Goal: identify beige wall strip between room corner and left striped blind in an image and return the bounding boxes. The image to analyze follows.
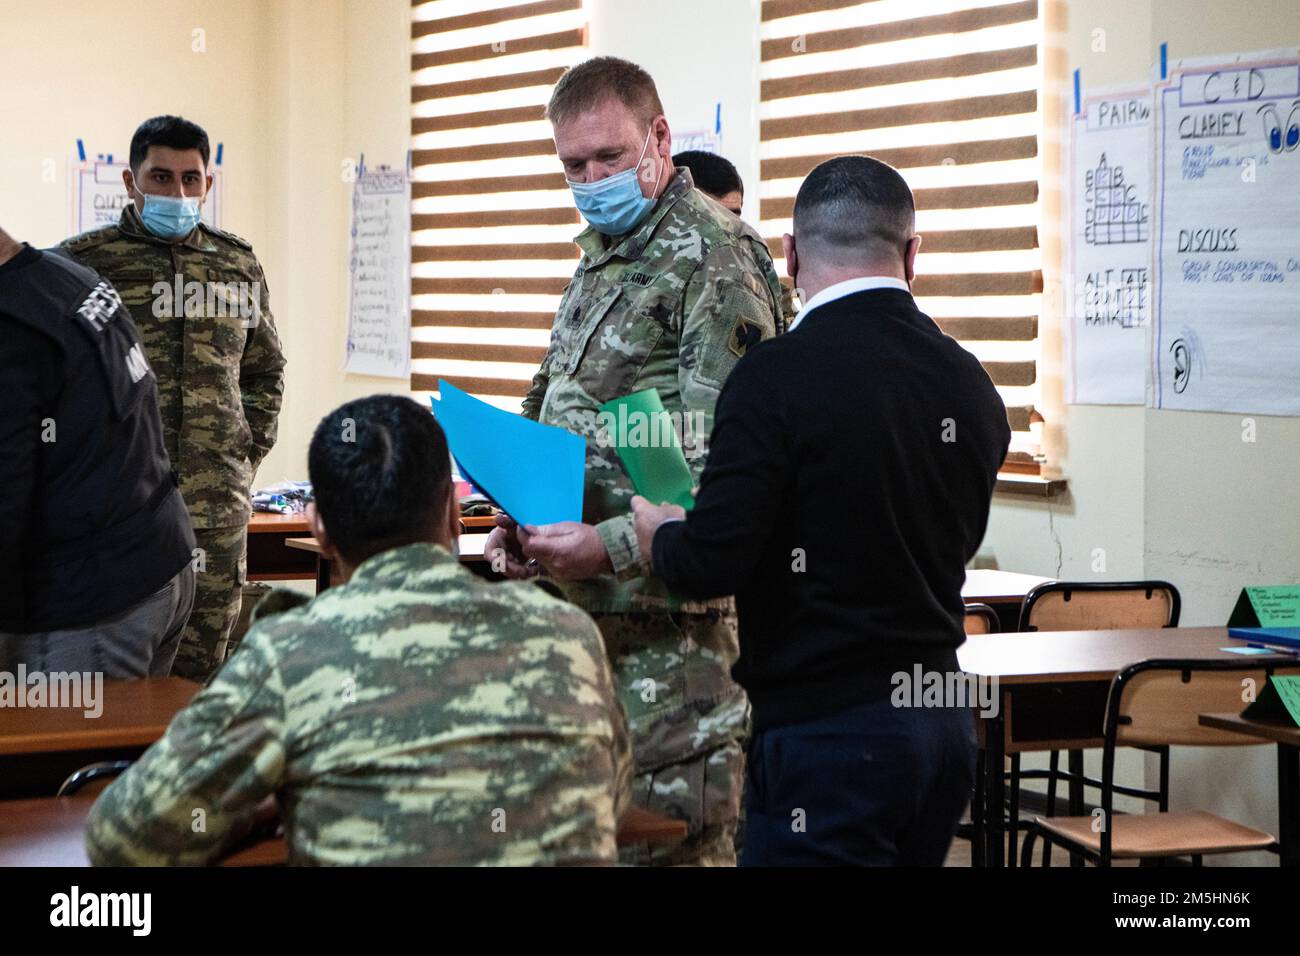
[259,0,411,484]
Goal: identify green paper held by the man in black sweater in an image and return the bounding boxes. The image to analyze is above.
[599,389,696,511]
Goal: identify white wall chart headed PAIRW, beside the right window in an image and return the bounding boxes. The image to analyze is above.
[1065,88,1152,405]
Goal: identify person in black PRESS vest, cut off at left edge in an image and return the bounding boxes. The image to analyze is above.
[0,230,194,680]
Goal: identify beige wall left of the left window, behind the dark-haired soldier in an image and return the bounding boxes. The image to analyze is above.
[0,0,411,494]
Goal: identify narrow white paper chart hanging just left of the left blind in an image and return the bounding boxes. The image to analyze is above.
[343,168,411,378]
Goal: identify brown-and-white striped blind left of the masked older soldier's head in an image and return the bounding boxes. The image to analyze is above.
[411,0,586,411]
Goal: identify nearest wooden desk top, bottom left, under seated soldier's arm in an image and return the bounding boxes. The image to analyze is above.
[0,793,289,868]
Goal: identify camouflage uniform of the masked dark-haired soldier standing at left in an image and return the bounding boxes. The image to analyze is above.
[62,206,285,680]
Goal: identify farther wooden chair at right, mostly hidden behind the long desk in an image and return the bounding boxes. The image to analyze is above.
[1008,580,1182,866]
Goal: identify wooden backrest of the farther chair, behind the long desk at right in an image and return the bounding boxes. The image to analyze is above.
[1021,581,1182,631]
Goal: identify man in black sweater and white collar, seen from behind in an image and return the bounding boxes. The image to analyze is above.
[633,156,1010,865]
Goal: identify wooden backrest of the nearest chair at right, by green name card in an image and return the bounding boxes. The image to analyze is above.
[1106,661,1300,747]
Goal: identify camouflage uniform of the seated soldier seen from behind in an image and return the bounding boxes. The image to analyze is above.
[86,544,632,865]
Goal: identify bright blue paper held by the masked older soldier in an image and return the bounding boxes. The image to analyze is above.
[432,378,586,524]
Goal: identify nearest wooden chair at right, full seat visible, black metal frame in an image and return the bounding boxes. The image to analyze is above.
[1021,659,1297,866]
